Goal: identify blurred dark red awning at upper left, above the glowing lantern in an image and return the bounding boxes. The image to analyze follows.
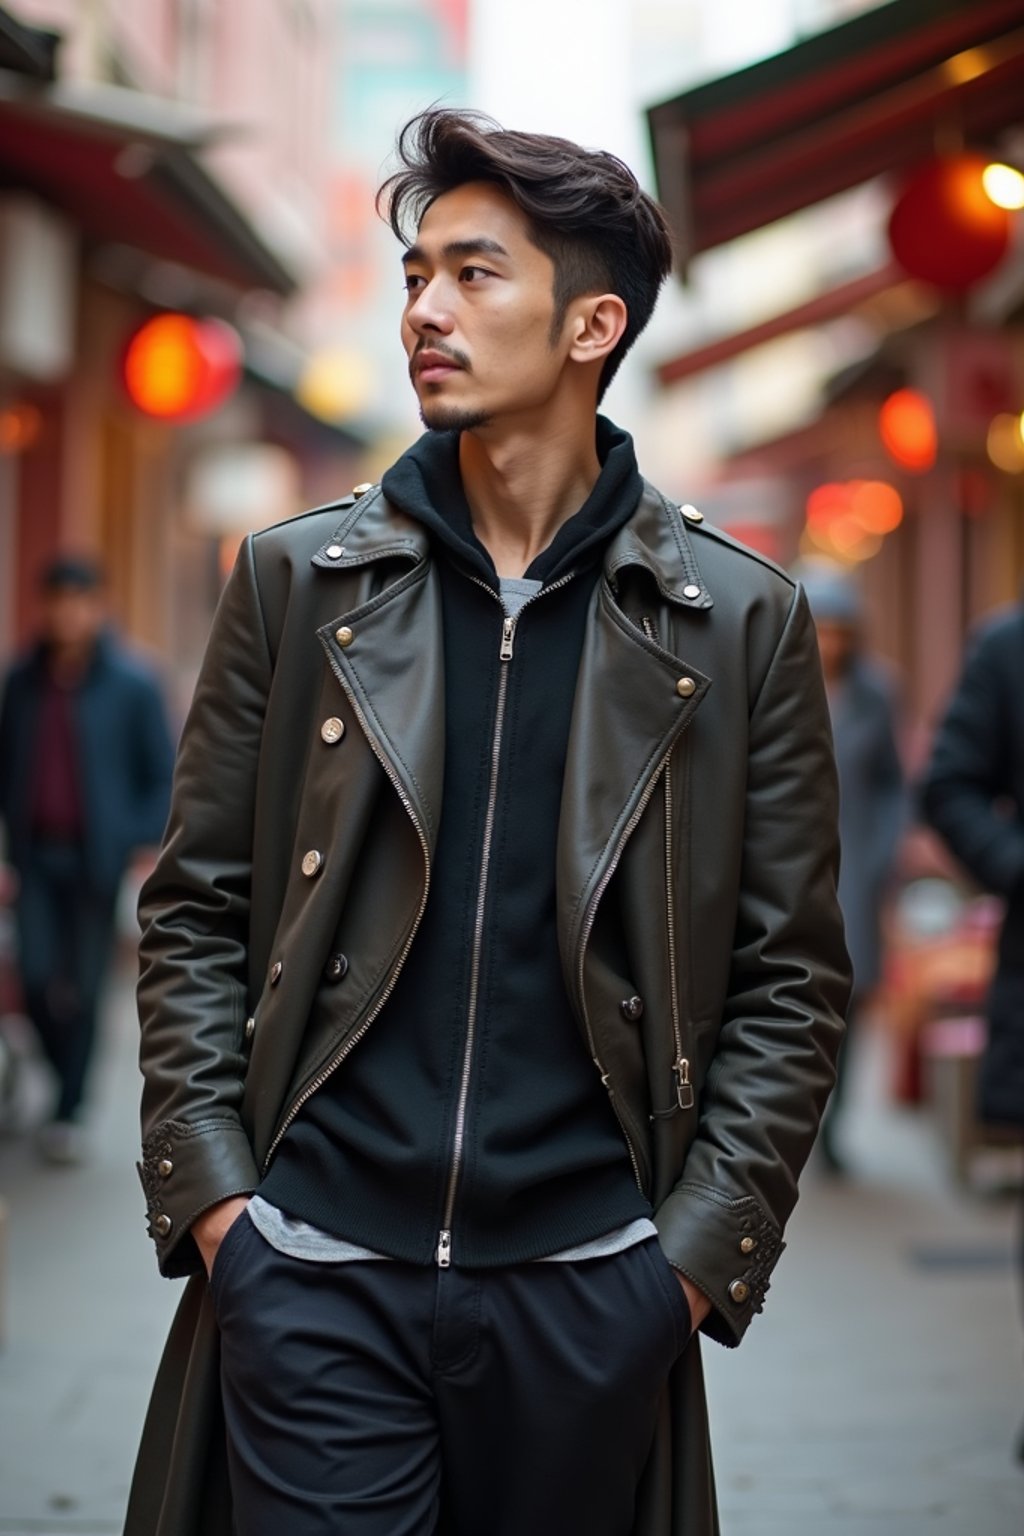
[0,69,298,293]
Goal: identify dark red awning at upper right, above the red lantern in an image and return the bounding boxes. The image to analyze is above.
[648,0,1024,275]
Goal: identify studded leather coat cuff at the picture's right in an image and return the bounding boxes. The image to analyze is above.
[654,1183,786,1346]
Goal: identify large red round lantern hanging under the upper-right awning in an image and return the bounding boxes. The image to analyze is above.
[889,154,1010,293]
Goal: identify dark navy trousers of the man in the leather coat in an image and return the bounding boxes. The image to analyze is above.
[212,1215,689,1536]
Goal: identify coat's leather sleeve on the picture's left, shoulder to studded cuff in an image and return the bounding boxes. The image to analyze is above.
[138,539,272,1275]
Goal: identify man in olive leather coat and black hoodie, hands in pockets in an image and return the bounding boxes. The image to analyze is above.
[127,111,847,1536]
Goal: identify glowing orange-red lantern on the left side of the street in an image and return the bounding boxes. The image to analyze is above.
[124,313,243,421]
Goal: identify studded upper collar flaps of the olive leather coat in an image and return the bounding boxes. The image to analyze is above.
[313,481,714,608]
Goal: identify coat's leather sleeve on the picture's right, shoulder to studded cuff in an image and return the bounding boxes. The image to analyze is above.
[654,590,851,1344]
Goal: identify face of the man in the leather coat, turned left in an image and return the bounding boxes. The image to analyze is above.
[402,181,571,432]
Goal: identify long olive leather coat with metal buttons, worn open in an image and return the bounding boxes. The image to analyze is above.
[126,487,849,1536]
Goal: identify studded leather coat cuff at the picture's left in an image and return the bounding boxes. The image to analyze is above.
[137,1120,259,1276]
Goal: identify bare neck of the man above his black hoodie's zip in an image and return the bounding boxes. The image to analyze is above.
[459,416,600,578]
